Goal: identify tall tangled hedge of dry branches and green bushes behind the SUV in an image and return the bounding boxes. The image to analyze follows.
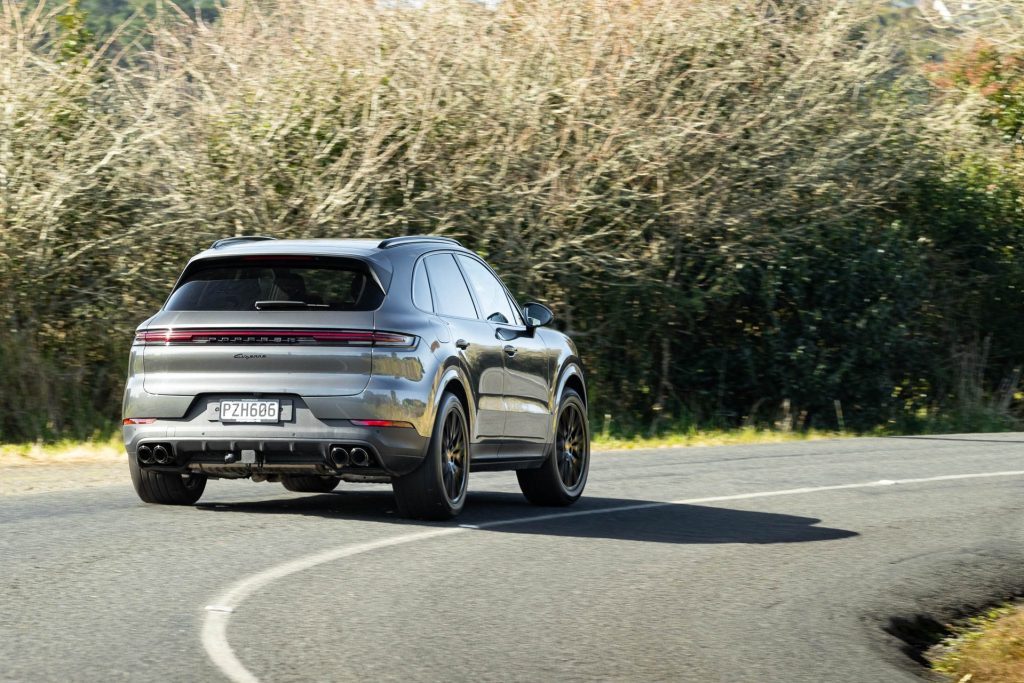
[0,0,1024,442]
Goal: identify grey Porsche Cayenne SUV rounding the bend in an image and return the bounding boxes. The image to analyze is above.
[123,237,590,519]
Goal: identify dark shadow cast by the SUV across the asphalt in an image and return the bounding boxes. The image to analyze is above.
[196,492,857,544]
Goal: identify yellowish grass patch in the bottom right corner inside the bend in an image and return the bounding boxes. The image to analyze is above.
[929,603,1024,683]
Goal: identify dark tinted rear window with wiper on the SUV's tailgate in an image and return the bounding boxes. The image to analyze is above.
[164,257,384,310]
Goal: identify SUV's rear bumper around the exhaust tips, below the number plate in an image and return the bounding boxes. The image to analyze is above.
[123,396,430,477]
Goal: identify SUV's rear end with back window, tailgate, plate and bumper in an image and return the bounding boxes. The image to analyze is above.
[124,240,433,489]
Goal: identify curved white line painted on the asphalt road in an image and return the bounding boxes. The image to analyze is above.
[202,470,1024,683]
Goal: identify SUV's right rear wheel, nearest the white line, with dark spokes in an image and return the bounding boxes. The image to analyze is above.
[392,393,469,519]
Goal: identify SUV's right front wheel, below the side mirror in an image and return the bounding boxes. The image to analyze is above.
[516,389,590,507]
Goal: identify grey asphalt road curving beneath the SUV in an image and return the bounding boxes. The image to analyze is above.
[0,434,1024,683]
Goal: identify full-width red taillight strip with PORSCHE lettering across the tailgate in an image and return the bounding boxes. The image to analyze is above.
[135,329,416,346]
